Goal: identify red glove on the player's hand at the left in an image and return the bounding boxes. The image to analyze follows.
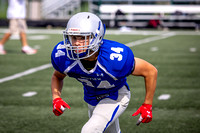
[53,98,70,116]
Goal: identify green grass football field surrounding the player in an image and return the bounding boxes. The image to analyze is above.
[0,28,200,133]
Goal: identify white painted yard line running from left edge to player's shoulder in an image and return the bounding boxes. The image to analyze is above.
[0,64,52,83]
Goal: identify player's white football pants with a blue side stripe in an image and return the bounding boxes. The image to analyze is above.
[81,86,131,133]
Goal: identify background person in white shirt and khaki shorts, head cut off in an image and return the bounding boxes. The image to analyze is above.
[0,0,37,55]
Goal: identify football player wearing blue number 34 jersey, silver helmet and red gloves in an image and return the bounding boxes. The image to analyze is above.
[51,12,157,133]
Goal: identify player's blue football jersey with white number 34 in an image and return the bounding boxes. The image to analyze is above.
[51,39,135,106]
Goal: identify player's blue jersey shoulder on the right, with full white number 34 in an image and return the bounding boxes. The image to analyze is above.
[99,40,135,78]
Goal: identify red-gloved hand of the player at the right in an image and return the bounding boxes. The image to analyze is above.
[132,103,153,126]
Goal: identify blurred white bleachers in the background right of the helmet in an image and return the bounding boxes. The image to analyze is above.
[88,0,200,28]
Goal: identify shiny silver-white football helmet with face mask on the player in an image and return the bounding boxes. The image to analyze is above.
[63,12,105,60]
